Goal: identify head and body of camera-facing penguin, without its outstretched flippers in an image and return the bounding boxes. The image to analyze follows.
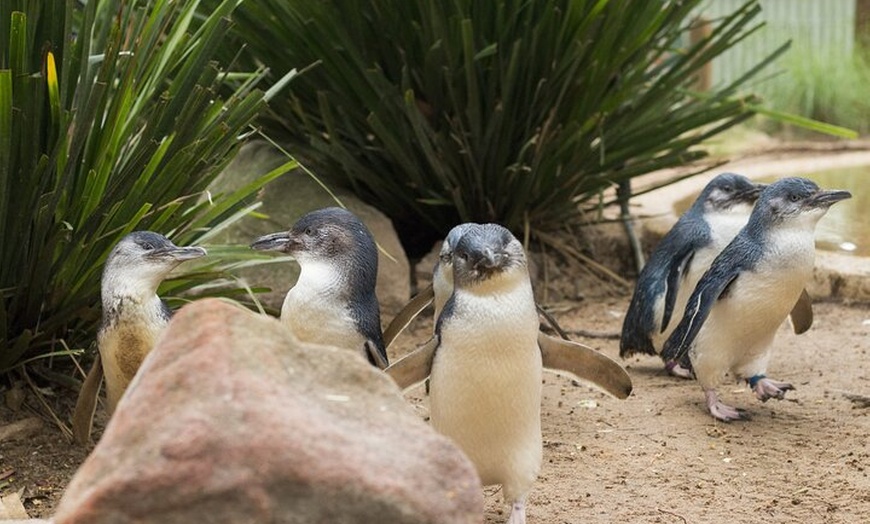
[429,224,543,524]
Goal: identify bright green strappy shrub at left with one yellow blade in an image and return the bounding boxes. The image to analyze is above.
[0,0,291,373]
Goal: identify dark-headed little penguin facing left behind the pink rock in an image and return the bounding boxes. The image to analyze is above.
[251,207,388,369]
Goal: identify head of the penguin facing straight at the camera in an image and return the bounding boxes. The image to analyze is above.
[453,224,526,287]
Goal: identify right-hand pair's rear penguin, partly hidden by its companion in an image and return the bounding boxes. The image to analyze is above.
[619,173,764,378]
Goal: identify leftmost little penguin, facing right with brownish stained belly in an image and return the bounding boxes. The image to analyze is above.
[73,231,206,443]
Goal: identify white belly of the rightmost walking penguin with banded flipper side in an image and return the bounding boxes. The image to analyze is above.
[692,235,814,387]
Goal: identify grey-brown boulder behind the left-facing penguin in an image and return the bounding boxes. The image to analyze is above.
[210,142,411,318]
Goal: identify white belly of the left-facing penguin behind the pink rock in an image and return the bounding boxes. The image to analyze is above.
[281,285,365,353]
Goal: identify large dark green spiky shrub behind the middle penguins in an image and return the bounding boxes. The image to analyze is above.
[215,0,782,255]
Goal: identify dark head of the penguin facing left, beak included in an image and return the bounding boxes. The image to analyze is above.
[251,207,378,272]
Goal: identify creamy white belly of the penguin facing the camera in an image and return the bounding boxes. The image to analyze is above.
[429,290,542,500]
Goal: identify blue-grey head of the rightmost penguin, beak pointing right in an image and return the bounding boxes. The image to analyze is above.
[753,177,852,226]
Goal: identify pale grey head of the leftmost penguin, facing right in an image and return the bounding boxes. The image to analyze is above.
[103,231,206,294]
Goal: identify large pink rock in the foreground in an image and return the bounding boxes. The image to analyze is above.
[55,299,483,524]
